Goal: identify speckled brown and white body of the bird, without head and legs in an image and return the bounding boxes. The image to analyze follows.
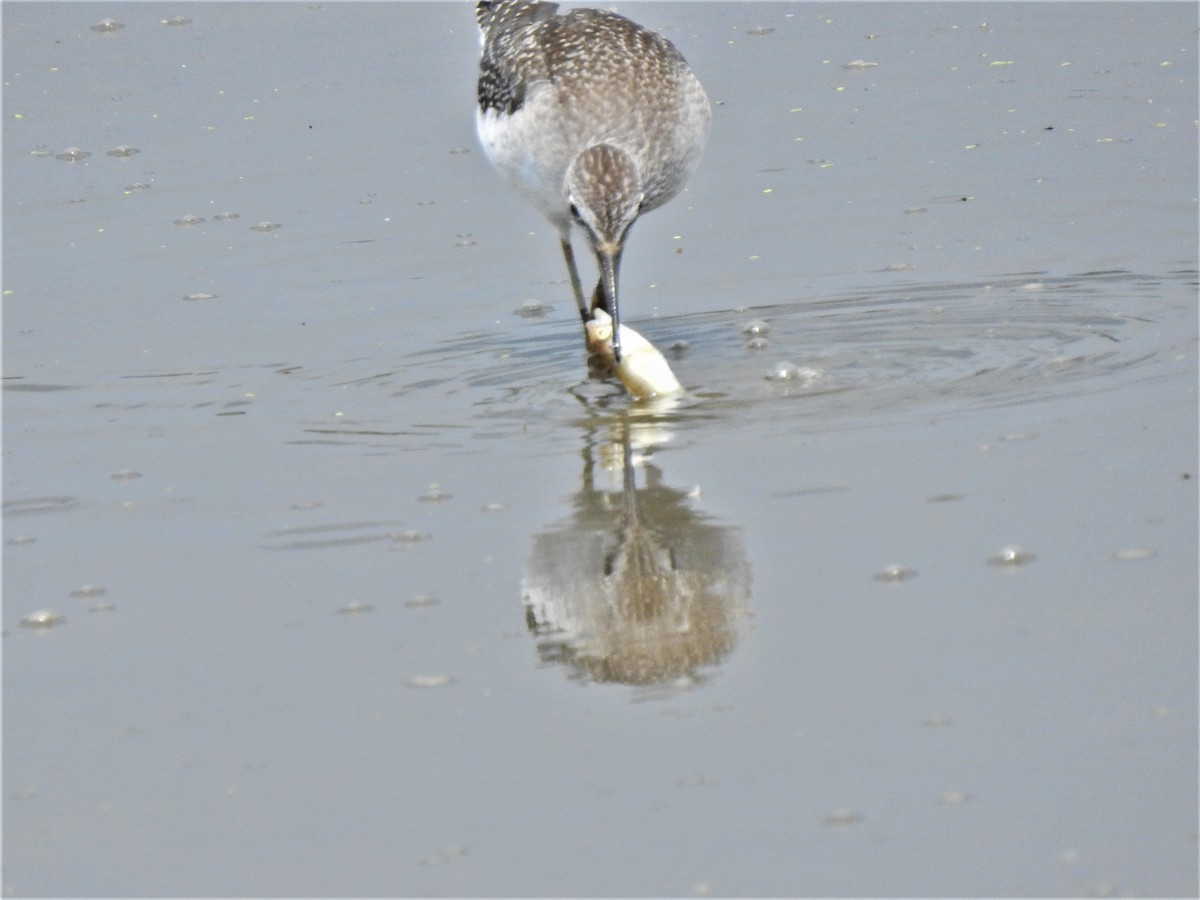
[476,0,712,220]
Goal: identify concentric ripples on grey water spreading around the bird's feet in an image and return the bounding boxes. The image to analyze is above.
[400,271,1195,434]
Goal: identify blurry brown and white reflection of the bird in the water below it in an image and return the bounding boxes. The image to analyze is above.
[522,414,750,686]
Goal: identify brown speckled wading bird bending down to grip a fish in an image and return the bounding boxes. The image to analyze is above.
[475,0,712,362]
